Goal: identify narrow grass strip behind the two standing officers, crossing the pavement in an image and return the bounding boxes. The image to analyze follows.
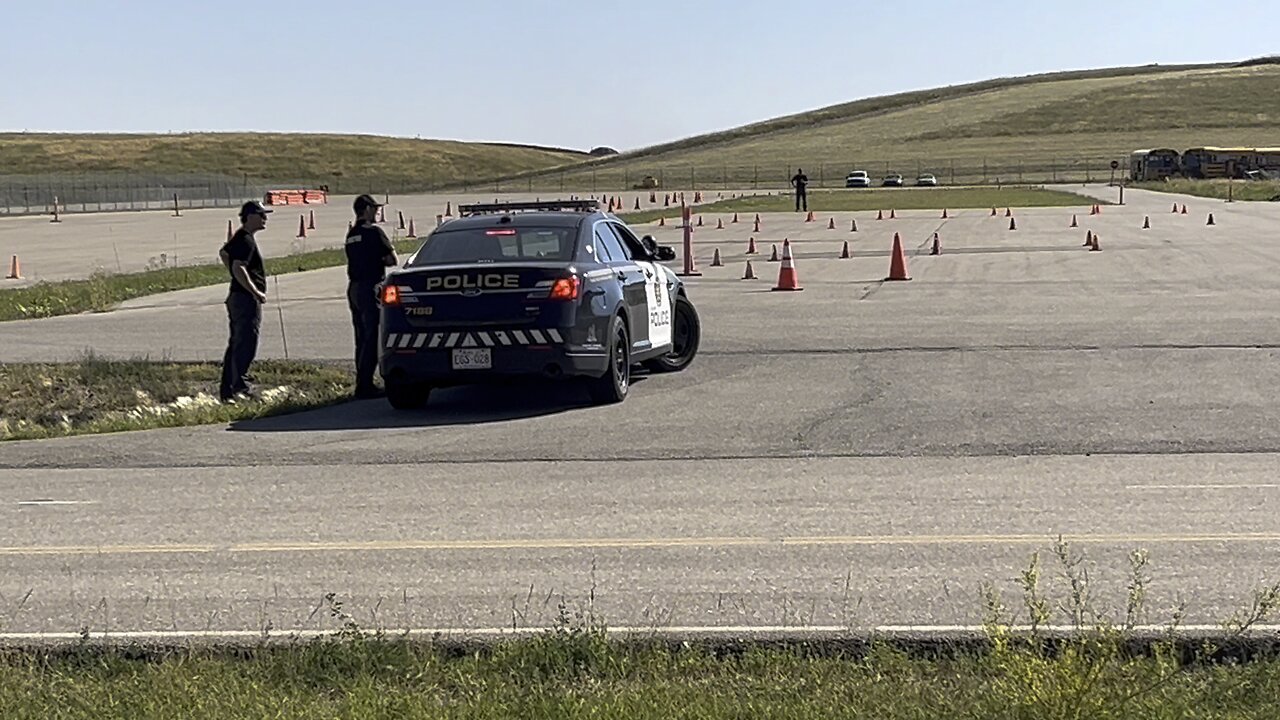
[0,240,421,322]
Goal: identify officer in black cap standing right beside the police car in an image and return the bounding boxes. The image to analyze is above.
[347,195,396,400]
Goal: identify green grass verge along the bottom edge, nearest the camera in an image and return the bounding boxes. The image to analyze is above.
[0,630,1280,720]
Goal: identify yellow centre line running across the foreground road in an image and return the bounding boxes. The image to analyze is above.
[0,533,1280,556]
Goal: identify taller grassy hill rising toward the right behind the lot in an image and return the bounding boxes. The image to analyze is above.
[496,59,1280,190]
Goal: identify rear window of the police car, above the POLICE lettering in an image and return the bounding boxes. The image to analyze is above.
[410,227,577,268]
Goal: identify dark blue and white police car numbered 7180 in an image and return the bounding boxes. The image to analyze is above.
[378,200,701,410]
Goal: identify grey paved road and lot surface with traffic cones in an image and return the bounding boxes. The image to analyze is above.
[0,188,1280,632]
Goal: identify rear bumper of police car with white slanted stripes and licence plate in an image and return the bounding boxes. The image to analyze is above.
[379,331,608,386]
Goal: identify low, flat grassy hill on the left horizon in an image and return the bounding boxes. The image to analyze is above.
[0,133,588,192]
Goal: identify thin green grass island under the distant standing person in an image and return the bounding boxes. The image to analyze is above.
[618,187,1107,223]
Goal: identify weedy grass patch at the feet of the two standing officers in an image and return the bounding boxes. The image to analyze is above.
[0,356,352,439]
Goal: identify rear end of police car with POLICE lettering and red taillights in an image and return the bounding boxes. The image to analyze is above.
[379,202,608,409]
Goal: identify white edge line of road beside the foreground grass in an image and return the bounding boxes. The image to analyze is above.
[0,625,1280,643]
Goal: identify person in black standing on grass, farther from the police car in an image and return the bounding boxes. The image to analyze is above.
[218,201,271,402]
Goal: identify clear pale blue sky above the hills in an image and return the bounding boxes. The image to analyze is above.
[0,0,1280,150]
